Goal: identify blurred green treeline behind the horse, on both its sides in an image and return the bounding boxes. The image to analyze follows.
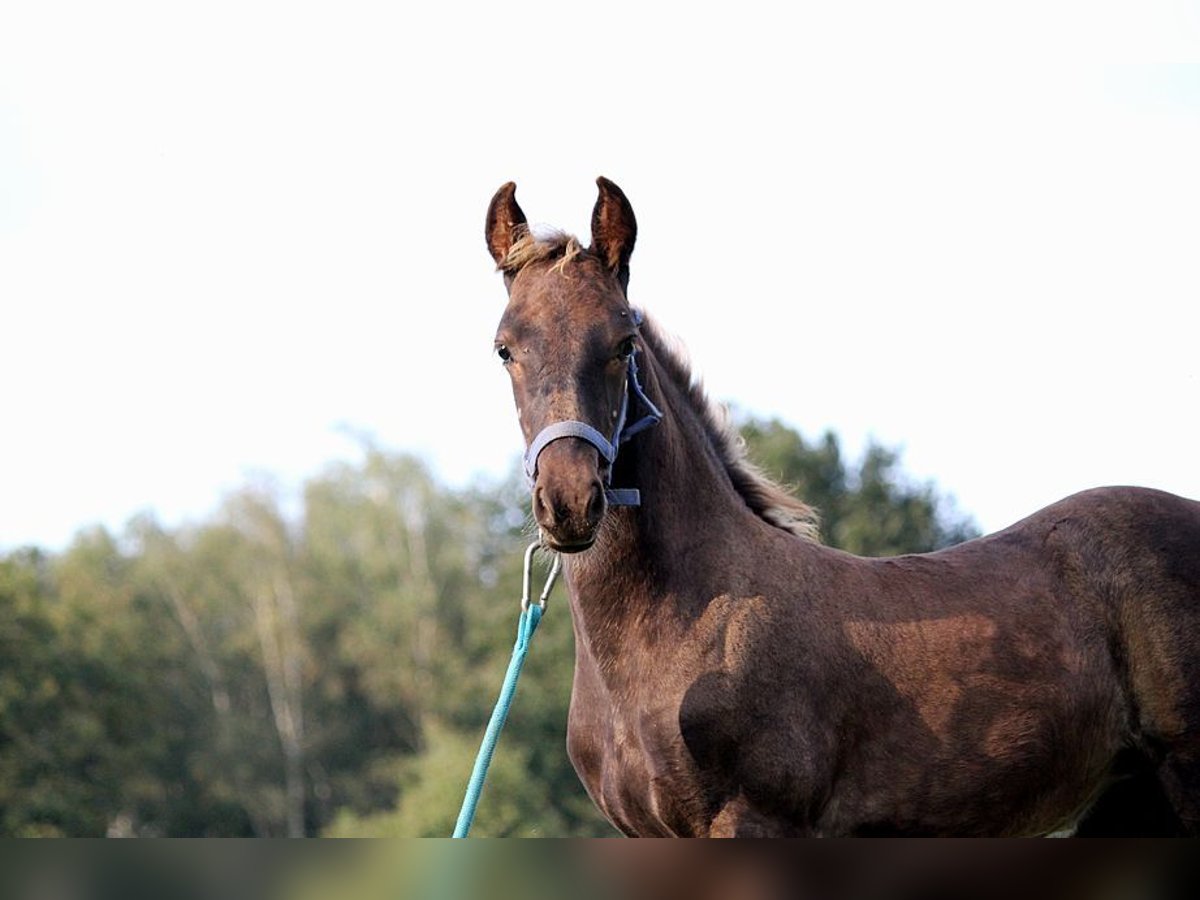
[0,421,974,836]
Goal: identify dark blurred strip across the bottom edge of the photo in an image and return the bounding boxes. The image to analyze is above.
[0,840,1200,900]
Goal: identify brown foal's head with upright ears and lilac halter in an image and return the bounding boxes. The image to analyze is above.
[486,178,659,553]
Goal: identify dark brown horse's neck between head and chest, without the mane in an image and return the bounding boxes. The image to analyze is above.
[565,338,754,637]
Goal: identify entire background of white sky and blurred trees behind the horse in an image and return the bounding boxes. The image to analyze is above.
[0,0,1200,836]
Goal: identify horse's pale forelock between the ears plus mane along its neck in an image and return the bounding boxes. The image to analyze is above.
[499,232,820,541]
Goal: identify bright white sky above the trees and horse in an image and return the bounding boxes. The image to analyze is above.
[0,0,1200,551]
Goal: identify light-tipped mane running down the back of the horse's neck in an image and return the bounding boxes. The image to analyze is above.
[642,320,820,541]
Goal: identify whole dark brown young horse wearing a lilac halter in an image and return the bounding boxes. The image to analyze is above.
[487,179,1200,836]
